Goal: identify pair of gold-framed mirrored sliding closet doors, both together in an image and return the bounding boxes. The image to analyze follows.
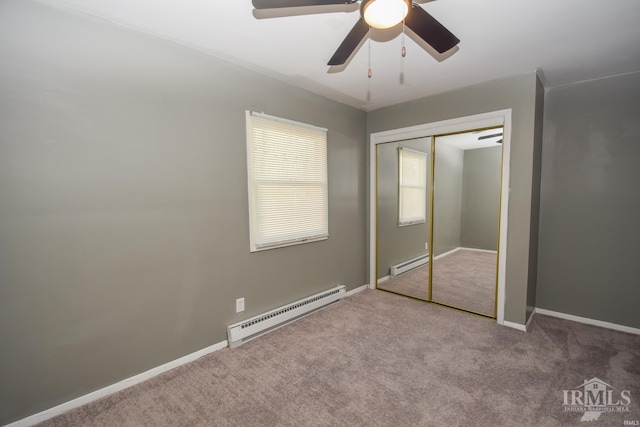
[376,128,502,318]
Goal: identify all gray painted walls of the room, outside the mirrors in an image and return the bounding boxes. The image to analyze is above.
[12,0,640,424]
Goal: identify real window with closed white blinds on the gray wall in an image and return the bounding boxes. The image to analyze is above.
[247,111,329,252]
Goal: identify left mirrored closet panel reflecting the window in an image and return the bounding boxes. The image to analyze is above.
[376,138,431,300]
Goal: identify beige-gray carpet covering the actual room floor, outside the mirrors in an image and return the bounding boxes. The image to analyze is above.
[37,290,640,427]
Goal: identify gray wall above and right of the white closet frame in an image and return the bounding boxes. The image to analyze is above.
[367,72,543,324]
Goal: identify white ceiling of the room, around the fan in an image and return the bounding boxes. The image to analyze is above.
[42,0,640,111]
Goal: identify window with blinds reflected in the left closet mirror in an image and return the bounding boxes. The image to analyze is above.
[398,147,427,226]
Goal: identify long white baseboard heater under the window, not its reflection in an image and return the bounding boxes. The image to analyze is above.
[227,285,347,348]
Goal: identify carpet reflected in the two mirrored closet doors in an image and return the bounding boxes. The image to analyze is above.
[378,250,497,317]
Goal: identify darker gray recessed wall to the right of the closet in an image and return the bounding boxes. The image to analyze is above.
[537,73,640,328]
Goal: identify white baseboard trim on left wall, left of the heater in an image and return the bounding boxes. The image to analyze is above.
[5,340,229,427]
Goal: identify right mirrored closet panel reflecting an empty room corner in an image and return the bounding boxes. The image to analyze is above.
[432,128,502,317]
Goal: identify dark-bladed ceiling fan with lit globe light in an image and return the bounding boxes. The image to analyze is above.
[252,0,460,66]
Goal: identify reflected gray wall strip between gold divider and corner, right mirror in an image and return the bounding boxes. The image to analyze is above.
[433,138,464,256]
